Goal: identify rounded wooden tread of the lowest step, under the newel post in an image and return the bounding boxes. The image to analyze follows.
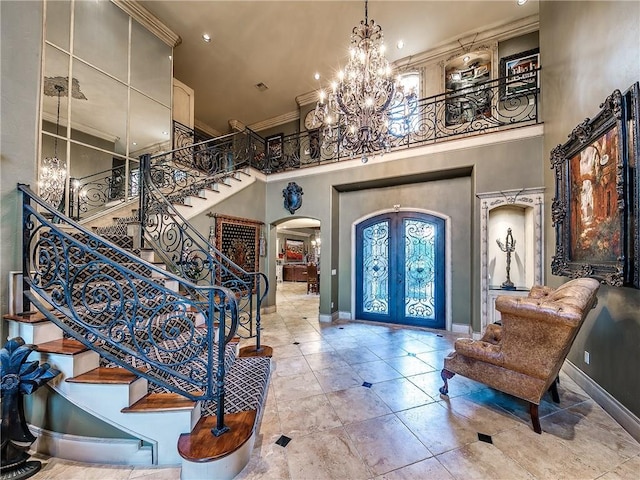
[178,410,257,462]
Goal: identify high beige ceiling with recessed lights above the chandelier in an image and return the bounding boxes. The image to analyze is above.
[140,0,538,133]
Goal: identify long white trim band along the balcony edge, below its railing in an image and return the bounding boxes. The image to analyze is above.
[265,124,544,183]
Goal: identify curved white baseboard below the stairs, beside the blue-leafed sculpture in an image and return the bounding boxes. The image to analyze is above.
[29,425,153,465]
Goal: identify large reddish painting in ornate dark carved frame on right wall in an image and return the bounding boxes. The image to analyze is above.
[551,90,630,286]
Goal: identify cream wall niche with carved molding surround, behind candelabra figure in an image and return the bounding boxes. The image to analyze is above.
[476,187,544,332]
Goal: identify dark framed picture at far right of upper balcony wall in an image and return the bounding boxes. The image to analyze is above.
[500,48,540,100]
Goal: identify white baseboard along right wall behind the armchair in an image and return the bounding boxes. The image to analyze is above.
[562,360,640,442]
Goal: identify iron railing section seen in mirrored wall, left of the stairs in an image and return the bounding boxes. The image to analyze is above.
[68,165,139,220]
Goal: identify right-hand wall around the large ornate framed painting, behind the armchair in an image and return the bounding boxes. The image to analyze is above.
[540,1,640,416]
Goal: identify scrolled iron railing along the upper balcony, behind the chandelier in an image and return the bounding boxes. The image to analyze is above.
[251,70,540,174]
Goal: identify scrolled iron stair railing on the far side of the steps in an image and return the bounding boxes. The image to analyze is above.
[140,150,269,350]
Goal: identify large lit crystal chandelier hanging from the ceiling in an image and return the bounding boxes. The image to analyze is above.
[314,1,404,163]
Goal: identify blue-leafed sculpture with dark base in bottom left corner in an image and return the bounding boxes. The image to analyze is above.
[0,337,60,480]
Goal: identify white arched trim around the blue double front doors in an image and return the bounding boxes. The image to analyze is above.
[350,207,452,331]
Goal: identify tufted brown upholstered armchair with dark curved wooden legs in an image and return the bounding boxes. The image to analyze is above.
[440,278,600,433]
